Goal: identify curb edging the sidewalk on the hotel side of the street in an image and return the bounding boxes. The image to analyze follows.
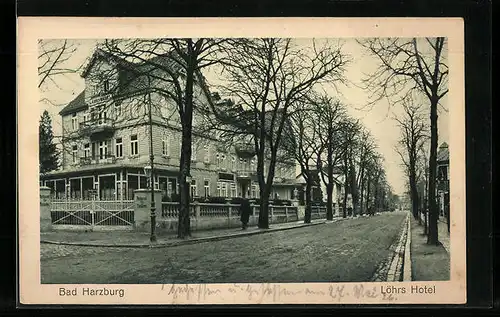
[40,219,336,248]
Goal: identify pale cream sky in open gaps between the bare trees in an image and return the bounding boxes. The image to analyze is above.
[40,39,449,195]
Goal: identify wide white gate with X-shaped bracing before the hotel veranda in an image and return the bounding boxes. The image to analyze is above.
[50,193,134,228]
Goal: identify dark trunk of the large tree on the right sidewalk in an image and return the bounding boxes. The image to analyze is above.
[427,96,439,245]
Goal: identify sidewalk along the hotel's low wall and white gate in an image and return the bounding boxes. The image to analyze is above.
[40,218,342,248]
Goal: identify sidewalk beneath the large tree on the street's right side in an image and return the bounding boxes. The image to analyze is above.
[410,217,450,281]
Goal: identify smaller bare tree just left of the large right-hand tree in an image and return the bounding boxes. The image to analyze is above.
[394,100,427,219]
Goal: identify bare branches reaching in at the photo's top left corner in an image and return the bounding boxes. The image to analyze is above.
[38,40,80,88]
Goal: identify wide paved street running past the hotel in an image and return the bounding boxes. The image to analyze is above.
[41,212,406,284]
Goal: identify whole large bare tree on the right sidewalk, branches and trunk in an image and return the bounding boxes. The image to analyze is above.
[359,37,449,245]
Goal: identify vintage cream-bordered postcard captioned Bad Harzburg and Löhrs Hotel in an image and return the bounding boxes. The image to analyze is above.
[17,17,467,305]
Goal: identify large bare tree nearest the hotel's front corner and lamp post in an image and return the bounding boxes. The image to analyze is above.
[95,38,225,238]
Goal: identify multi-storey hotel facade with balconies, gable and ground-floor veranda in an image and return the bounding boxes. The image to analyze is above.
[41,49,296,201]
